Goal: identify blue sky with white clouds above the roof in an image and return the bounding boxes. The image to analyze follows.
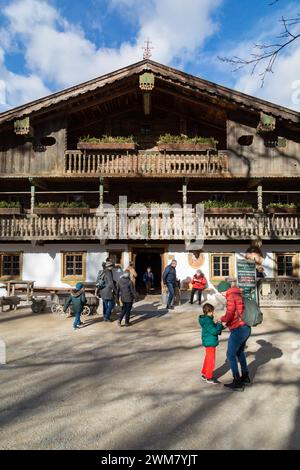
[0,0,300,112]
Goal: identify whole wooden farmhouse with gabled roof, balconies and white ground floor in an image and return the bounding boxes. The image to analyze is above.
[0,60,300,305]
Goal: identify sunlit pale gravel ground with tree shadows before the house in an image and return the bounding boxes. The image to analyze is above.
[0,297,300,450]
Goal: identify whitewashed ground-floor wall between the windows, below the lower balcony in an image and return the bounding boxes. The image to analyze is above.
[0,243,300,287]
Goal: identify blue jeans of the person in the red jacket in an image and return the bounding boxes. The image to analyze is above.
[227,325,251,376]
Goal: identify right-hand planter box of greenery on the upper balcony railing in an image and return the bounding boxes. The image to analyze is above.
[157,134,218,152]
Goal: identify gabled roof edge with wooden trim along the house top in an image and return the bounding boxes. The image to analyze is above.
[0,60,300,124]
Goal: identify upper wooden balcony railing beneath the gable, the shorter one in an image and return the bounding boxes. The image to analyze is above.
[64,150,229,177]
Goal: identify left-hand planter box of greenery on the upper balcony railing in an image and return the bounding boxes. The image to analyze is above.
[77,135,136,150]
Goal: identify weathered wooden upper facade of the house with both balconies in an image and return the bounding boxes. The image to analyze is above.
[0,60,300,294]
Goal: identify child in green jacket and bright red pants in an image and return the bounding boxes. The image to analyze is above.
[199,304,224,384]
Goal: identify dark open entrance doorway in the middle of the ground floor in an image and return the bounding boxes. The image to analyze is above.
[135,249,162,294]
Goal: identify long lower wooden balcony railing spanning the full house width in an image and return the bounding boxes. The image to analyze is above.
[0,212,300,242]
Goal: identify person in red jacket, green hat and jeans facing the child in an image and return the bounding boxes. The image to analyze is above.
[217,281,251,391]
